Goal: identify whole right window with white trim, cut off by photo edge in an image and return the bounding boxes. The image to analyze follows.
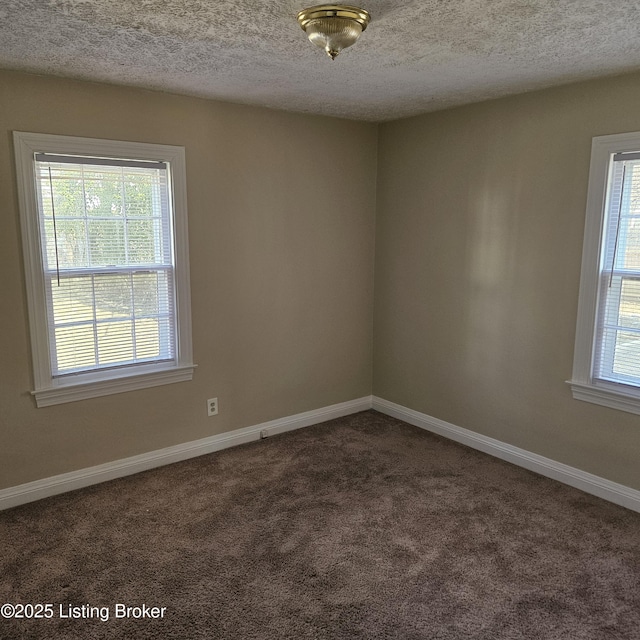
[570,133,640,414]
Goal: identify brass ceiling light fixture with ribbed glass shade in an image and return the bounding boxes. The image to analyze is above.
[298,4,371,60]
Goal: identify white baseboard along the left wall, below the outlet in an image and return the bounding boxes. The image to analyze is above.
[0,396,371,510]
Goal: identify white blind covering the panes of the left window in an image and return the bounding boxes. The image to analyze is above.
[35,153,176,378]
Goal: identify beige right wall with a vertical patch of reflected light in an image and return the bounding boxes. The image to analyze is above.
[374,75,640,489]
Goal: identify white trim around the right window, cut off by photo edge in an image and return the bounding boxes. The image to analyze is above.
[568,132,640,414]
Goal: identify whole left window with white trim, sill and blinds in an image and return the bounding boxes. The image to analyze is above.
[14,132,193,407]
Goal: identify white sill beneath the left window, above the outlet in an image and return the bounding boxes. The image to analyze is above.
[31,365,196,407]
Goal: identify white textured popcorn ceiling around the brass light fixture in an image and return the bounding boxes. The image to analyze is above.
[0,0,640,121]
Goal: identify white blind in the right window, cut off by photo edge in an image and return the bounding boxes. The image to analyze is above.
[593,153,640,386]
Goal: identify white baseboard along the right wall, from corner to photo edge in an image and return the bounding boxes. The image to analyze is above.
[372,396,640,512]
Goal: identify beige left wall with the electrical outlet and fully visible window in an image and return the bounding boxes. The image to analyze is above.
[0,72,377,488]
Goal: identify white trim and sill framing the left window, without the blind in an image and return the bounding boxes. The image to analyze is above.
[13,131,195,407]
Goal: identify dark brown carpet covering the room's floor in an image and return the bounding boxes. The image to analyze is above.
[0,411,640,640]
